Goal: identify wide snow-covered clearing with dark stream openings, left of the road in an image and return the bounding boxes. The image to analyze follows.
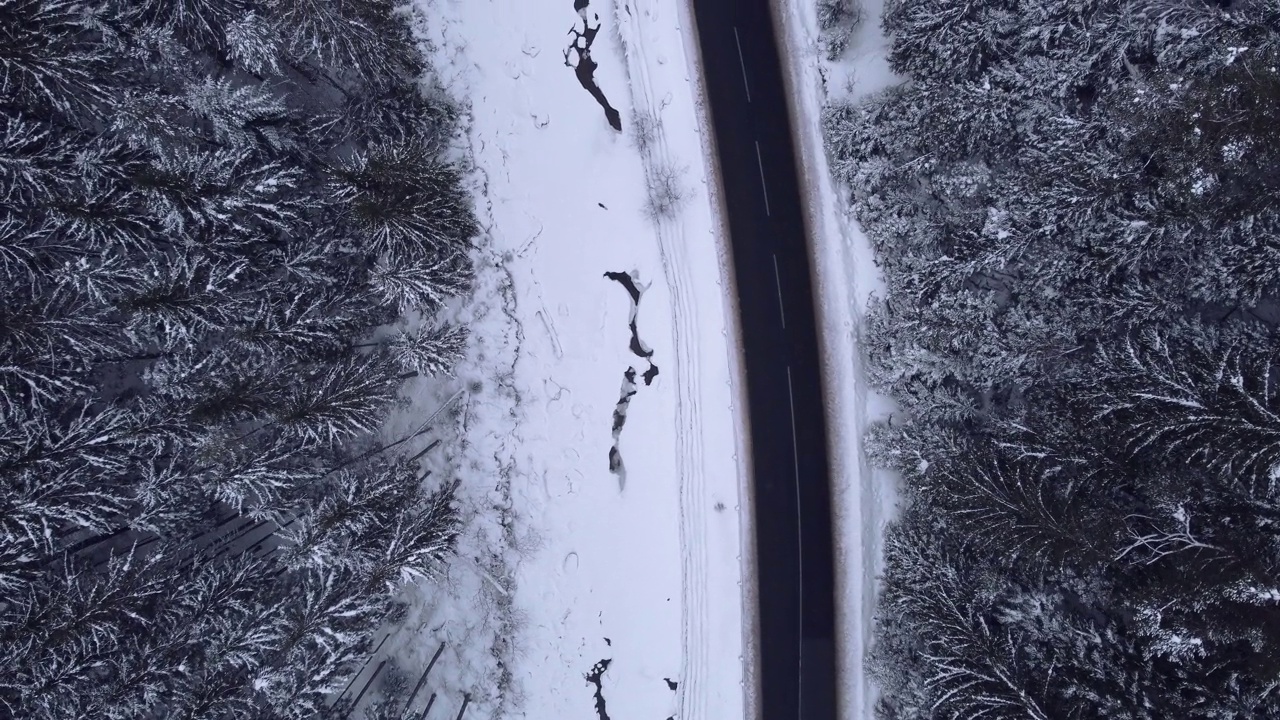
[358,0,754,720]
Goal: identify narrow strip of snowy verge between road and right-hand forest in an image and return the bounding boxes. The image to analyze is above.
[773,0,895,720]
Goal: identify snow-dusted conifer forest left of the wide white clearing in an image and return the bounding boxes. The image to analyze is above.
[0,0,476,720]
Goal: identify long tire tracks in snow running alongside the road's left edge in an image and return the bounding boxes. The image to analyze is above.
[614,0,710,720]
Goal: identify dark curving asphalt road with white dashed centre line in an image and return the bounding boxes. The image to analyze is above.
[694,0,836,720]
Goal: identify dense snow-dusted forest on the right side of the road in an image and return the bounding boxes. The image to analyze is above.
[824,0,1280,720]
